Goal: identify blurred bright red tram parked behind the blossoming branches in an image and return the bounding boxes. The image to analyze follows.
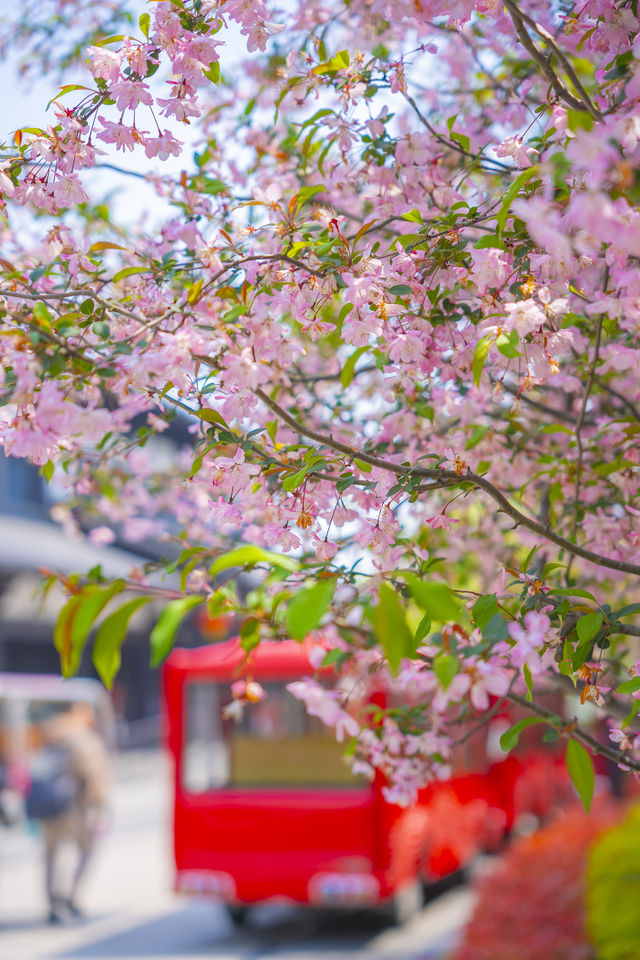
[164,640,561,919]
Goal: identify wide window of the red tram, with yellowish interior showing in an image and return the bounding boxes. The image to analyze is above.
[182,682,362,793]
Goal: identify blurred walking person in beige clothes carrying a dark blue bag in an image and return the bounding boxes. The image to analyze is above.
[26,703,109,924]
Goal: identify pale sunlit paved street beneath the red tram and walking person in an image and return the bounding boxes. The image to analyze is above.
[0,753,471,960]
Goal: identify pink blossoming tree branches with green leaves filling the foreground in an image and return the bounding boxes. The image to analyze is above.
[0,0,640,802]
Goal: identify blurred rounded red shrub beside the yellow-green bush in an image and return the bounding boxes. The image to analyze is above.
[452,803,617,960]
